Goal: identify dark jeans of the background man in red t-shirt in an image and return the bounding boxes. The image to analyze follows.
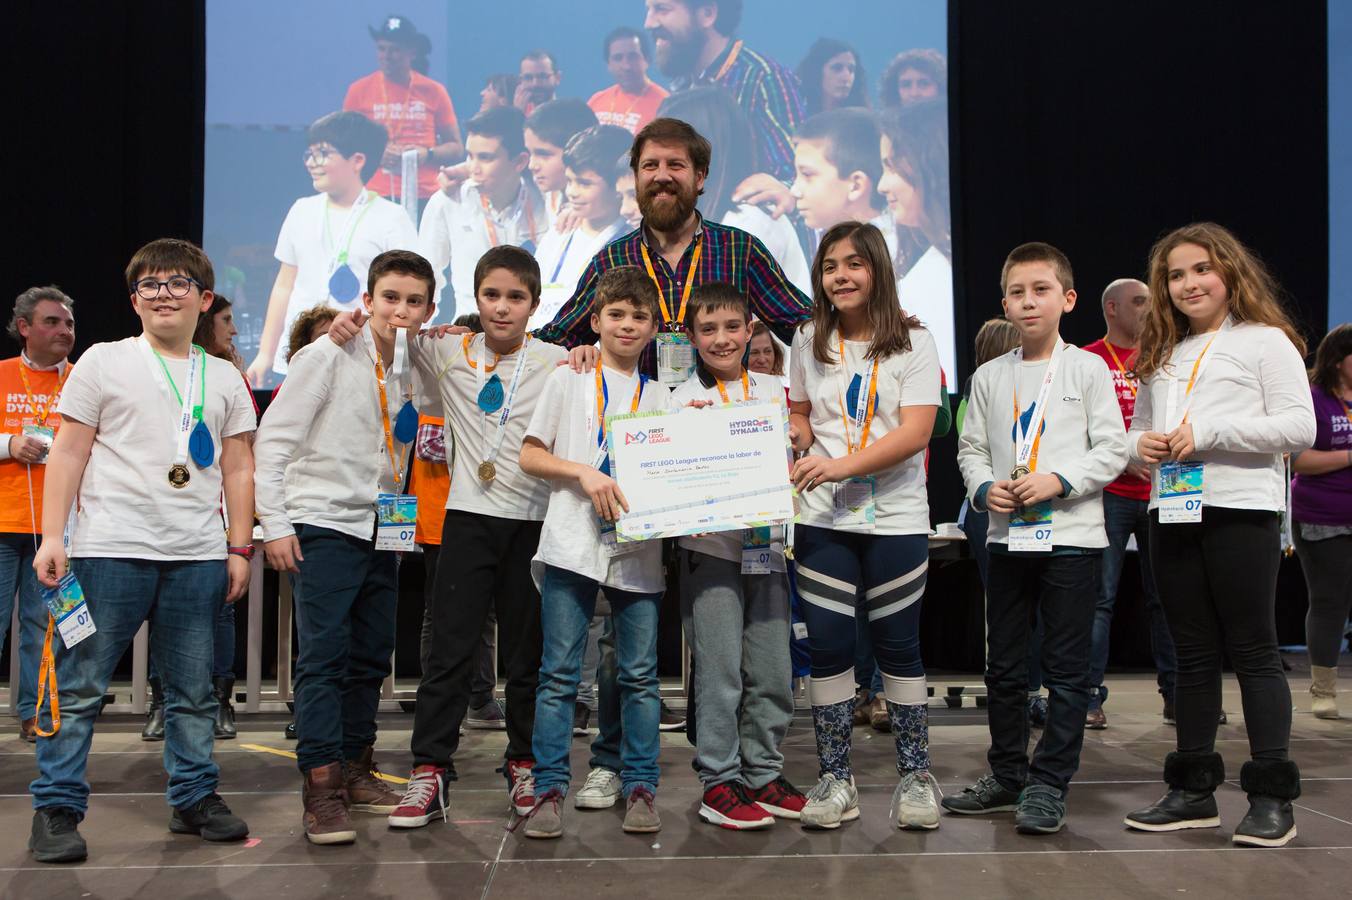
[1090,491,1178,705]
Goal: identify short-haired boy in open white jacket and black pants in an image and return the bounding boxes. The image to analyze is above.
[944,243,1126,834]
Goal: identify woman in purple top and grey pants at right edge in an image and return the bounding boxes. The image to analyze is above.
[1291,323,1352,719]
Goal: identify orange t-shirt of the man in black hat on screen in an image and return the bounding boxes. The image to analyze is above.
[342,72,456,200]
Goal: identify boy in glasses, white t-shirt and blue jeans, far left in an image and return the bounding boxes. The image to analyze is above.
[28,239,256,862]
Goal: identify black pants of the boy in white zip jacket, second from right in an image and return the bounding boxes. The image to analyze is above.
[986,551,1102,791]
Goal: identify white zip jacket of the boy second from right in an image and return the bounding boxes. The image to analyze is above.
[957,347,1128,547]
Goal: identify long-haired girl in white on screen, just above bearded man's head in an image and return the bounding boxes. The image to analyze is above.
[657,86,811,293]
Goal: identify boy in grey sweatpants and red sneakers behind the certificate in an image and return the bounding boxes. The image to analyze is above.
[672,282,807,831]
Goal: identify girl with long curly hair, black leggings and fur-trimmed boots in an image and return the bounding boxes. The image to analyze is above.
[1126,223,1315,847]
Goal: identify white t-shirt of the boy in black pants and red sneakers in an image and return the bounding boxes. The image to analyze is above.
[416,334,568,522]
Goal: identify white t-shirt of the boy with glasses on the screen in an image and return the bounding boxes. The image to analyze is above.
[272,192,418,374]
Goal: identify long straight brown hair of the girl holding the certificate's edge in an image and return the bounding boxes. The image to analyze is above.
[804,222,921,365]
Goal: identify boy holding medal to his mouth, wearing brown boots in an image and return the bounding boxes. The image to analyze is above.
[254,250,437,845]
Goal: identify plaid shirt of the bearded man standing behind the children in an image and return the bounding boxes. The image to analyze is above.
[535,214,813,378]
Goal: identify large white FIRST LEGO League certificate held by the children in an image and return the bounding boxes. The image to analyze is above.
[608,401,796,542]
